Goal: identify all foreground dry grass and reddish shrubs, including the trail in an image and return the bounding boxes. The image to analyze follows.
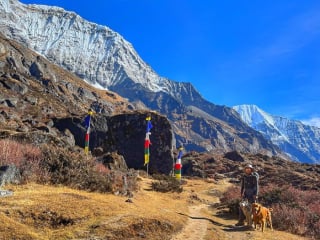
[0,140,320,240]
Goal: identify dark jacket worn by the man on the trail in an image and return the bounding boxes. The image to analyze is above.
[241,172,259,201]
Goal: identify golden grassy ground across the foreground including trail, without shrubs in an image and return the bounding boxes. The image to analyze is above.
[0,177,310,240]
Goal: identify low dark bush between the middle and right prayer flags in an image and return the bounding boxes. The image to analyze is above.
[151,175,183,193]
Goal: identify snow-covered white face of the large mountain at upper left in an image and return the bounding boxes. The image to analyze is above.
[0,0,168,91]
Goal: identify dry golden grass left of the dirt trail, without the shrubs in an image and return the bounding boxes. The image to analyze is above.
[0,179,186,239]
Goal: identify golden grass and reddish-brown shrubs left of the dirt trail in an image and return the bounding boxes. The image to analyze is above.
[0,140,183,239]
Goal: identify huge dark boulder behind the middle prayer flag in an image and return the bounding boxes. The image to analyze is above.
[103,112,174,174]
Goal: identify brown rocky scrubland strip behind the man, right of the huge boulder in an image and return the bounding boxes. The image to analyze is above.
[182,151,320,191]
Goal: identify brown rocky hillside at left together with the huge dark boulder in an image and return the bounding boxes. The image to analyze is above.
[0,34,175,174]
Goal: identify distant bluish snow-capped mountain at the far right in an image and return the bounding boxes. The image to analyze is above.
[233,105,320,163]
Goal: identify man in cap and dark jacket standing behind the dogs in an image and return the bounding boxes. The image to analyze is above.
[236,164,259,226]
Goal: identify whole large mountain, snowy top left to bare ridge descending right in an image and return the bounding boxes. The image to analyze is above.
[0,0,279,155]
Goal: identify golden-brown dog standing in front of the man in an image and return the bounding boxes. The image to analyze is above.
[251,203,273,232]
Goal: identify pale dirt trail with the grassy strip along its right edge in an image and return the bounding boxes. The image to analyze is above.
[172,180,308,240]
